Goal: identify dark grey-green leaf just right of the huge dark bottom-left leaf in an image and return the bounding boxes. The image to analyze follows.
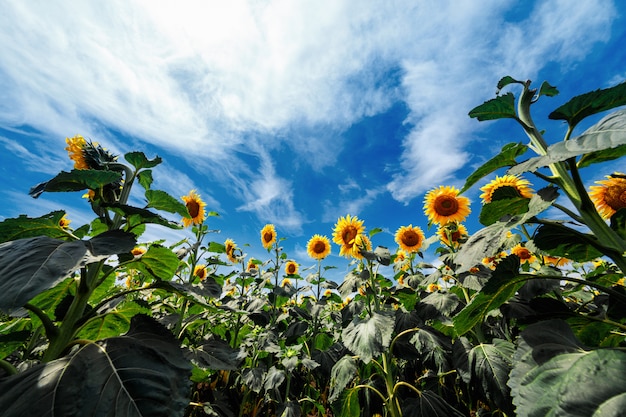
[185,335,245,371]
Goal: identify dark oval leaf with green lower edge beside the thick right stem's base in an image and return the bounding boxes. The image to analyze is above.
[533,223,603,262]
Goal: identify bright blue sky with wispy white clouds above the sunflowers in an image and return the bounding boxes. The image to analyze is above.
[0,0,626,280]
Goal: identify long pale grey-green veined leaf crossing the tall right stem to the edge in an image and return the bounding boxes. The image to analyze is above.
[508,110,626,175]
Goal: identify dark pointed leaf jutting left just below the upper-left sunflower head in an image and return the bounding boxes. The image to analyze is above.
[28,169,122,198]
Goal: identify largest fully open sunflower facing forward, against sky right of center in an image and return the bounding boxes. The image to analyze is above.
[424,185,470,224]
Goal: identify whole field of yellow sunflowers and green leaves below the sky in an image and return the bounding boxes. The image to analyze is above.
[0,76,626,417]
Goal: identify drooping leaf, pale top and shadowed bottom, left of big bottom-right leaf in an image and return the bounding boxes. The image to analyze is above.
[468,339,515,413]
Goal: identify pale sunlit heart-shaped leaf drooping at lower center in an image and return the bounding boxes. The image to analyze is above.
[341,311,395,363]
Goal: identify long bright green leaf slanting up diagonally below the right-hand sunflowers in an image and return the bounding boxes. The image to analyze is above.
[454,255,526,336]
